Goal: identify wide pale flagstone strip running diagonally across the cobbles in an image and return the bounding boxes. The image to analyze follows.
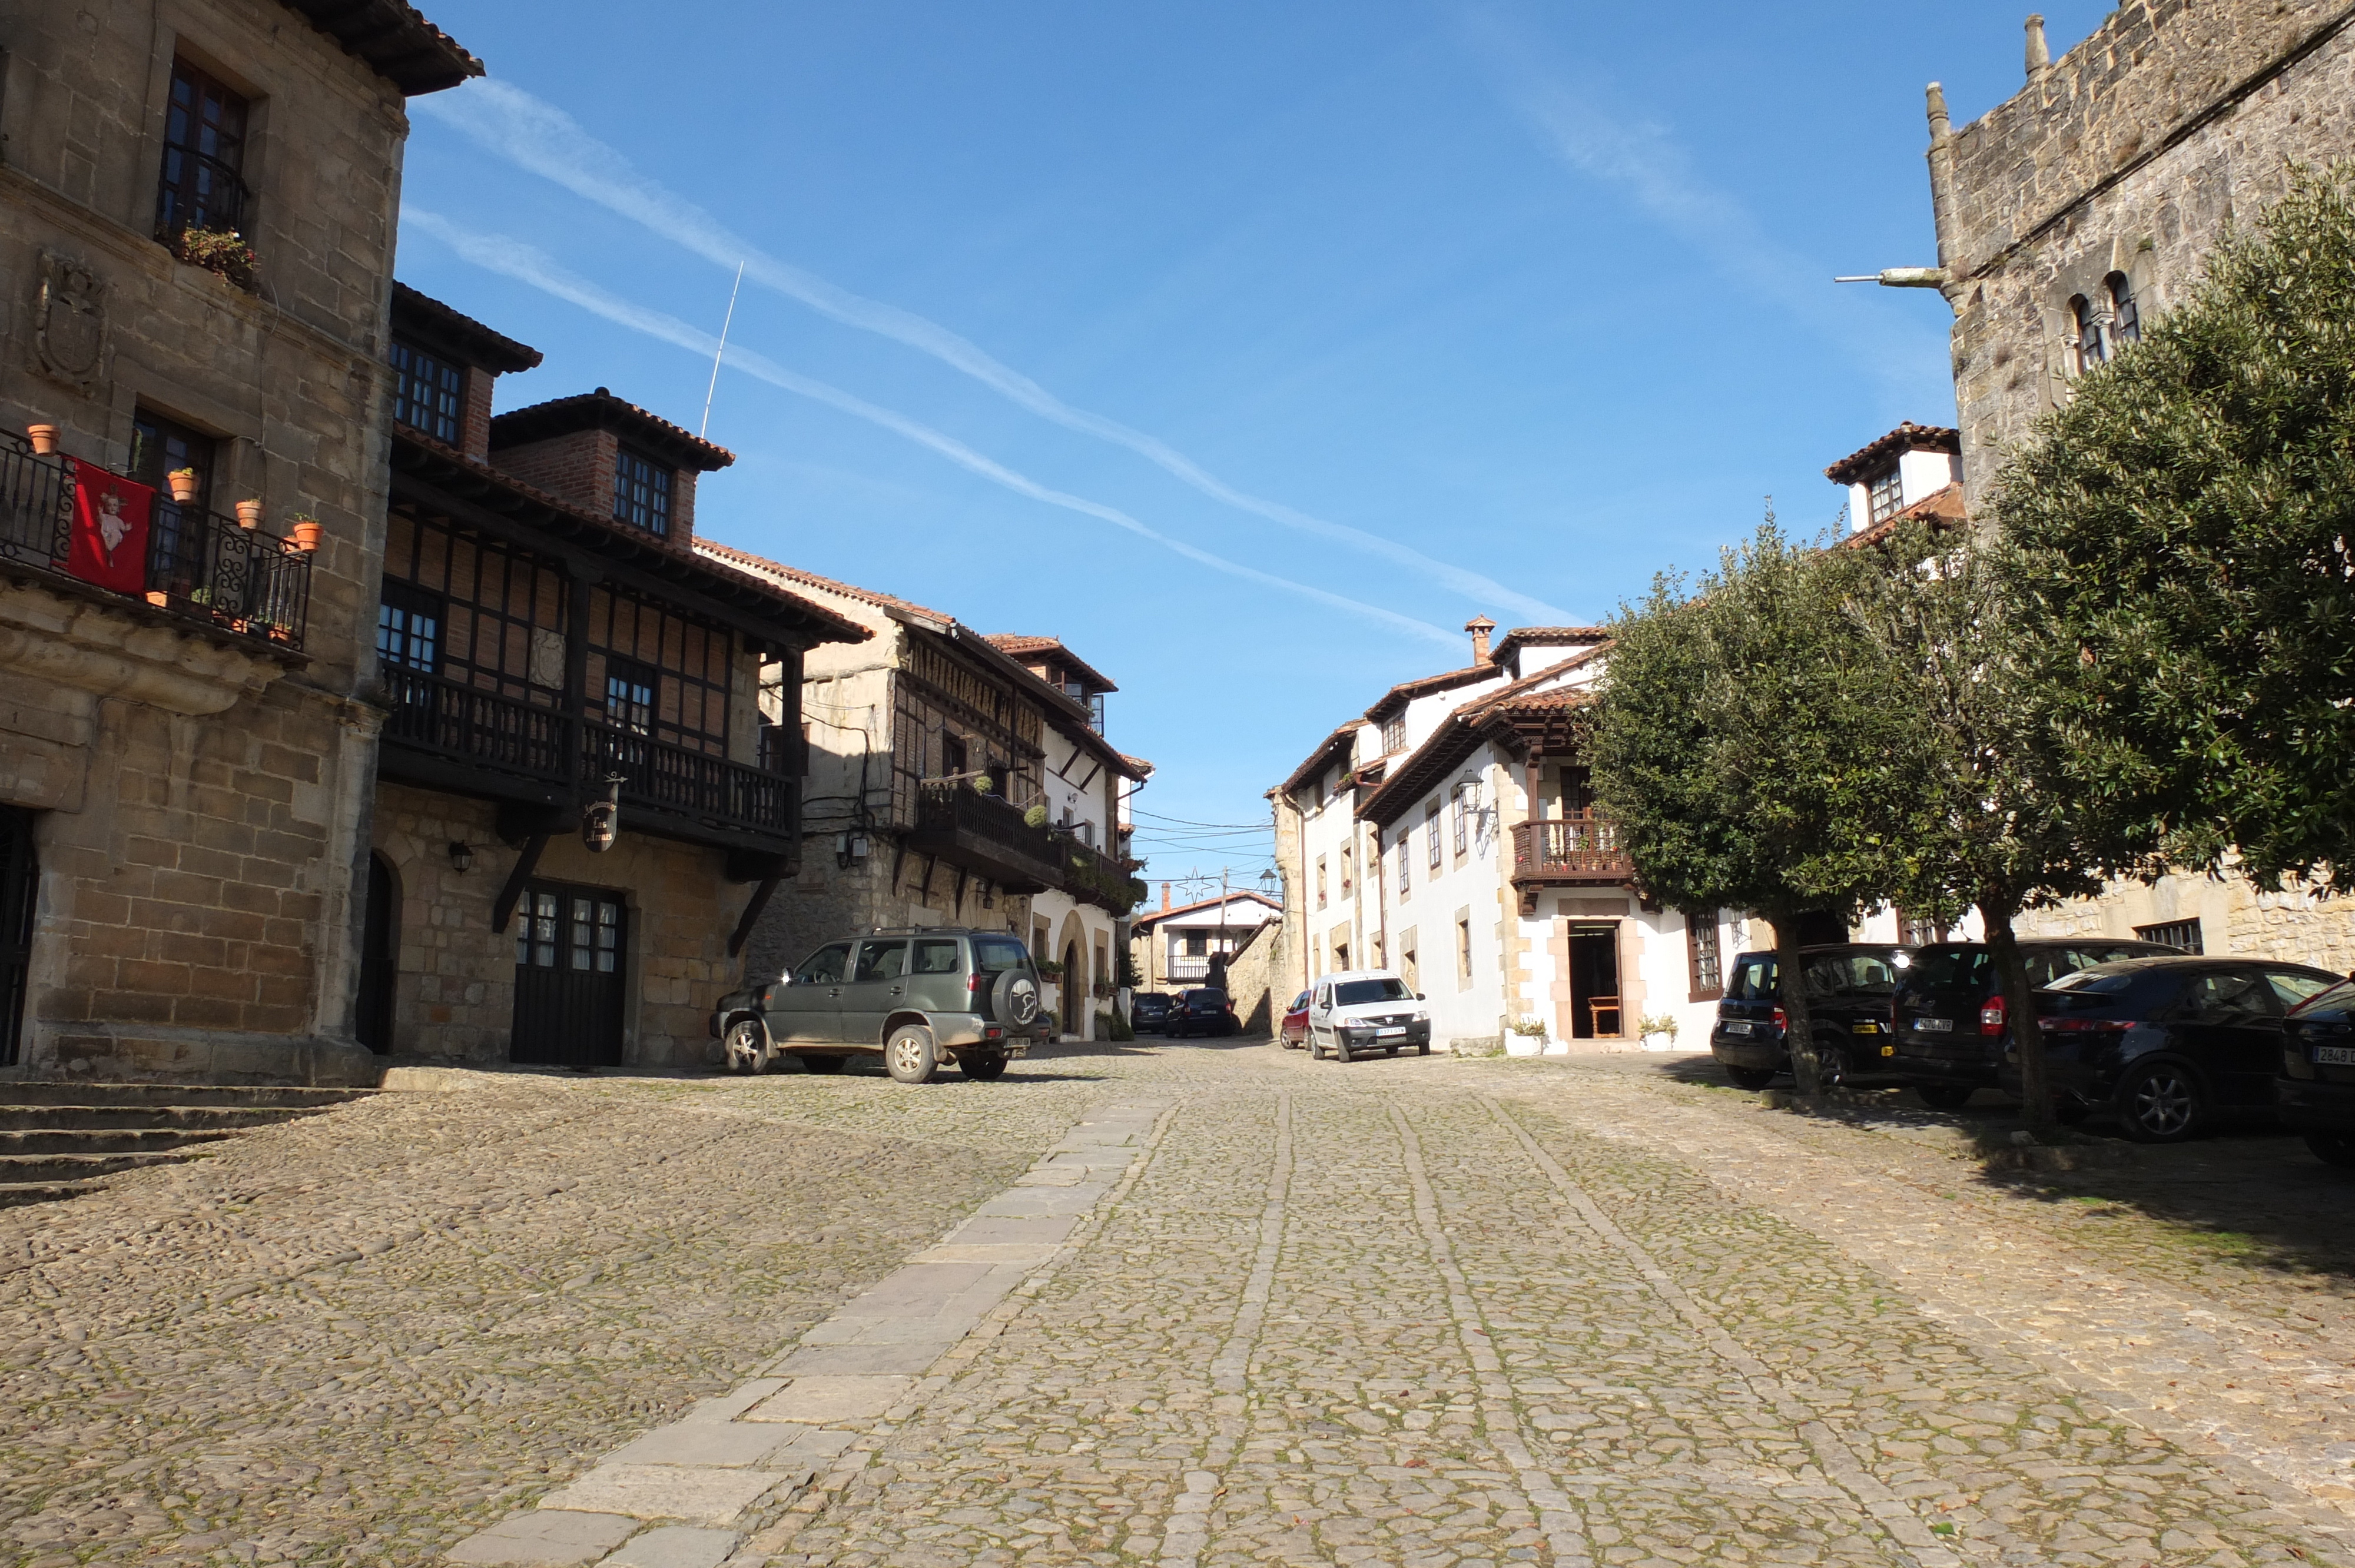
[447,1099,1163,1568]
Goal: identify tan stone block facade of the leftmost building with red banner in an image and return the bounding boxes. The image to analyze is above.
[0,0,407,1076]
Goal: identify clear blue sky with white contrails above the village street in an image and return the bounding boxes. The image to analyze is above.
[400,0,2108,881]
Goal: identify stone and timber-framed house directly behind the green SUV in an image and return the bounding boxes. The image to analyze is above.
[697,542,1152,1038]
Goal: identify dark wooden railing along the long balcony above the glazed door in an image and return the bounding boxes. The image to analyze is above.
[384,664,801,838]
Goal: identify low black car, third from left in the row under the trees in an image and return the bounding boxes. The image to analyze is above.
[2002,956,2339,1144]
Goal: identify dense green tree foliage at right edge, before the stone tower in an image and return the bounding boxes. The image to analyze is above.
[1992,167,2355,890]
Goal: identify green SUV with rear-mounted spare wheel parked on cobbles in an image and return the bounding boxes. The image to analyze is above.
[711,925,1039,1083]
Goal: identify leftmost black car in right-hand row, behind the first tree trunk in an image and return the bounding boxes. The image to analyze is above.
[1710,942,1910,1088]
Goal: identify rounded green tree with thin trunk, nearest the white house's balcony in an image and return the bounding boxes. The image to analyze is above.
[1590,516,1903,1095]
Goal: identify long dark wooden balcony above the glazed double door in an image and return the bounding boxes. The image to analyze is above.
[382,666,801,857]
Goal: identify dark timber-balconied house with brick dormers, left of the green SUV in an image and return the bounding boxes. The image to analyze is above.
[360,290,869,1067]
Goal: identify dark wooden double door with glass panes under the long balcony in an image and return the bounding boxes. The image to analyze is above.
[506,883,629,1067]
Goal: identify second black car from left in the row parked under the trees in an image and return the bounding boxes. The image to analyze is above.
[1889,937,2183,1111]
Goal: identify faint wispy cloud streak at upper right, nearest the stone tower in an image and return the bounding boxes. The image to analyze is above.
[1462,5,1948,398]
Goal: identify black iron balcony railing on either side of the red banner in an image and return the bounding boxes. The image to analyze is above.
[0,431,311,650]
